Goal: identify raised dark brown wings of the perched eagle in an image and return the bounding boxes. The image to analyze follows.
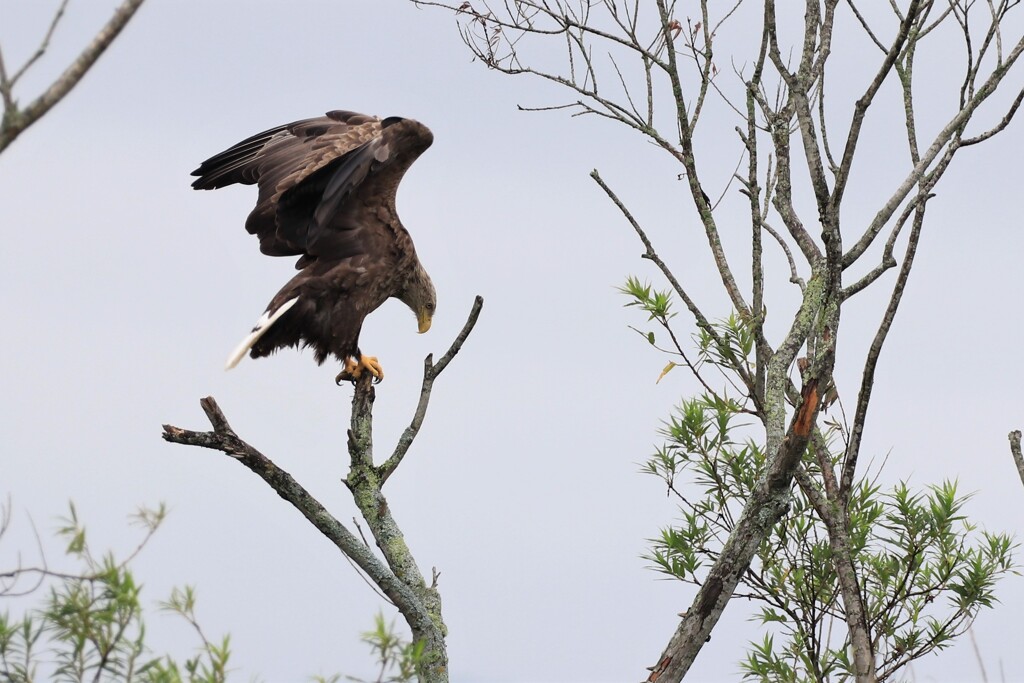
[193,112,433,267]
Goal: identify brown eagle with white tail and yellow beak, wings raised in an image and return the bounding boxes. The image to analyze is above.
[193,112,437,383]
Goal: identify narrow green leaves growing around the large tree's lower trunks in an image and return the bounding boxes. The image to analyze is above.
[623,299,1016,681]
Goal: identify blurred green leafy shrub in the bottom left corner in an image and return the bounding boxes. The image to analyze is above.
[0,504,229,683]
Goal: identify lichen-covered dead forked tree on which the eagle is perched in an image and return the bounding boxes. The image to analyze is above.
[164,297,483,683]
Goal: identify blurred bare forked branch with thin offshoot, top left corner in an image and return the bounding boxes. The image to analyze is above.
[0,0,144,153]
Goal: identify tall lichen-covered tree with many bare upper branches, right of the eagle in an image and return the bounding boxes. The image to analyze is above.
[412,0,1024,683]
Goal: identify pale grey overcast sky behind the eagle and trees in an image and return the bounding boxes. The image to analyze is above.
[0,0,1024,683]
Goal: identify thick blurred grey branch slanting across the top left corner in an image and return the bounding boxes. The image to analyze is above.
[0,0,144,152]
